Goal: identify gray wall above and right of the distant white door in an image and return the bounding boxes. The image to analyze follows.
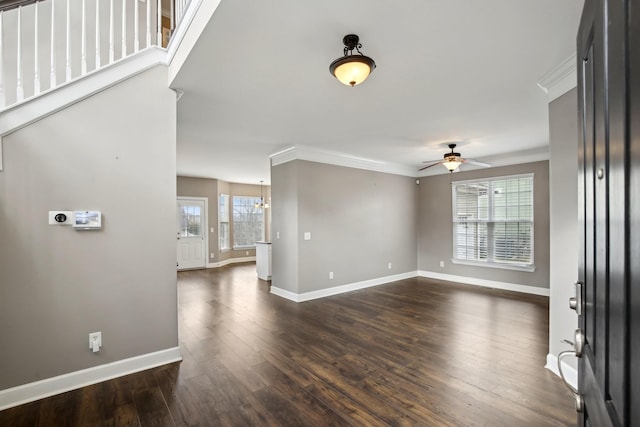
[176,176,222,263]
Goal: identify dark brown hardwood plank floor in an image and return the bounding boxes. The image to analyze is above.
[0,264,575,427]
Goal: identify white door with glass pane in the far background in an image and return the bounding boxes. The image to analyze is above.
[176,197,207,270]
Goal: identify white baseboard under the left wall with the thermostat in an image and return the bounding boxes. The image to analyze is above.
[0,347,182,411]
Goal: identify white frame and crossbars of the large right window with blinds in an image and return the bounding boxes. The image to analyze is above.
[451,173,535,272]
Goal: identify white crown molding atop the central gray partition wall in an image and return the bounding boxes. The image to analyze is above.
[269,145,416,177]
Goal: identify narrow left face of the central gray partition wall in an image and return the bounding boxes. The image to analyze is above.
[271,161,300,294]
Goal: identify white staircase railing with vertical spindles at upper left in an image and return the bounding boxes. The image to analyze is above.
[0,0,190,111]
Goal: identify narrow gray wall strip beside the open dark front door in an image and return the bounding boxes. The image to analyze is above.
[549,89,579,367]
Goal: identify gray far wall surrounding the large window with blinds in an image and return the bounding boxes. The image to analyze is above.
[418,161,549,288]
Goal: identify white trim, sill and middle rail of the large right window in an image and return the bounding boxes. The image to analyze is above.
[451,172,536,272]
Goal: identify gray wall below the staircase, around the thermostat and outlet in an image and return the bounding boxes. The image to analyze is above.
[0,67,178,389]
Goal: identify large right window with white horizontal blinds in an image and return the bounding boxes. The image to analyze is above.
[452,174,533,269]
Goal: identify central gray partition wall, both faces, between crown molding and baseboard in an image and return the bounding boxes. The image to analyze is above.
[272,160,417,293]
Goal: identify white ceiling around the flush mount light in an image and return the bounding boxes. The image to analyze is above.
[172,0,583,183]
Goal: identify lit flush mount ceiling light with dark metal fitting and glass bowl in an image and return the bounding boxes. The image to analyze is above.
[329,34,376,87]
